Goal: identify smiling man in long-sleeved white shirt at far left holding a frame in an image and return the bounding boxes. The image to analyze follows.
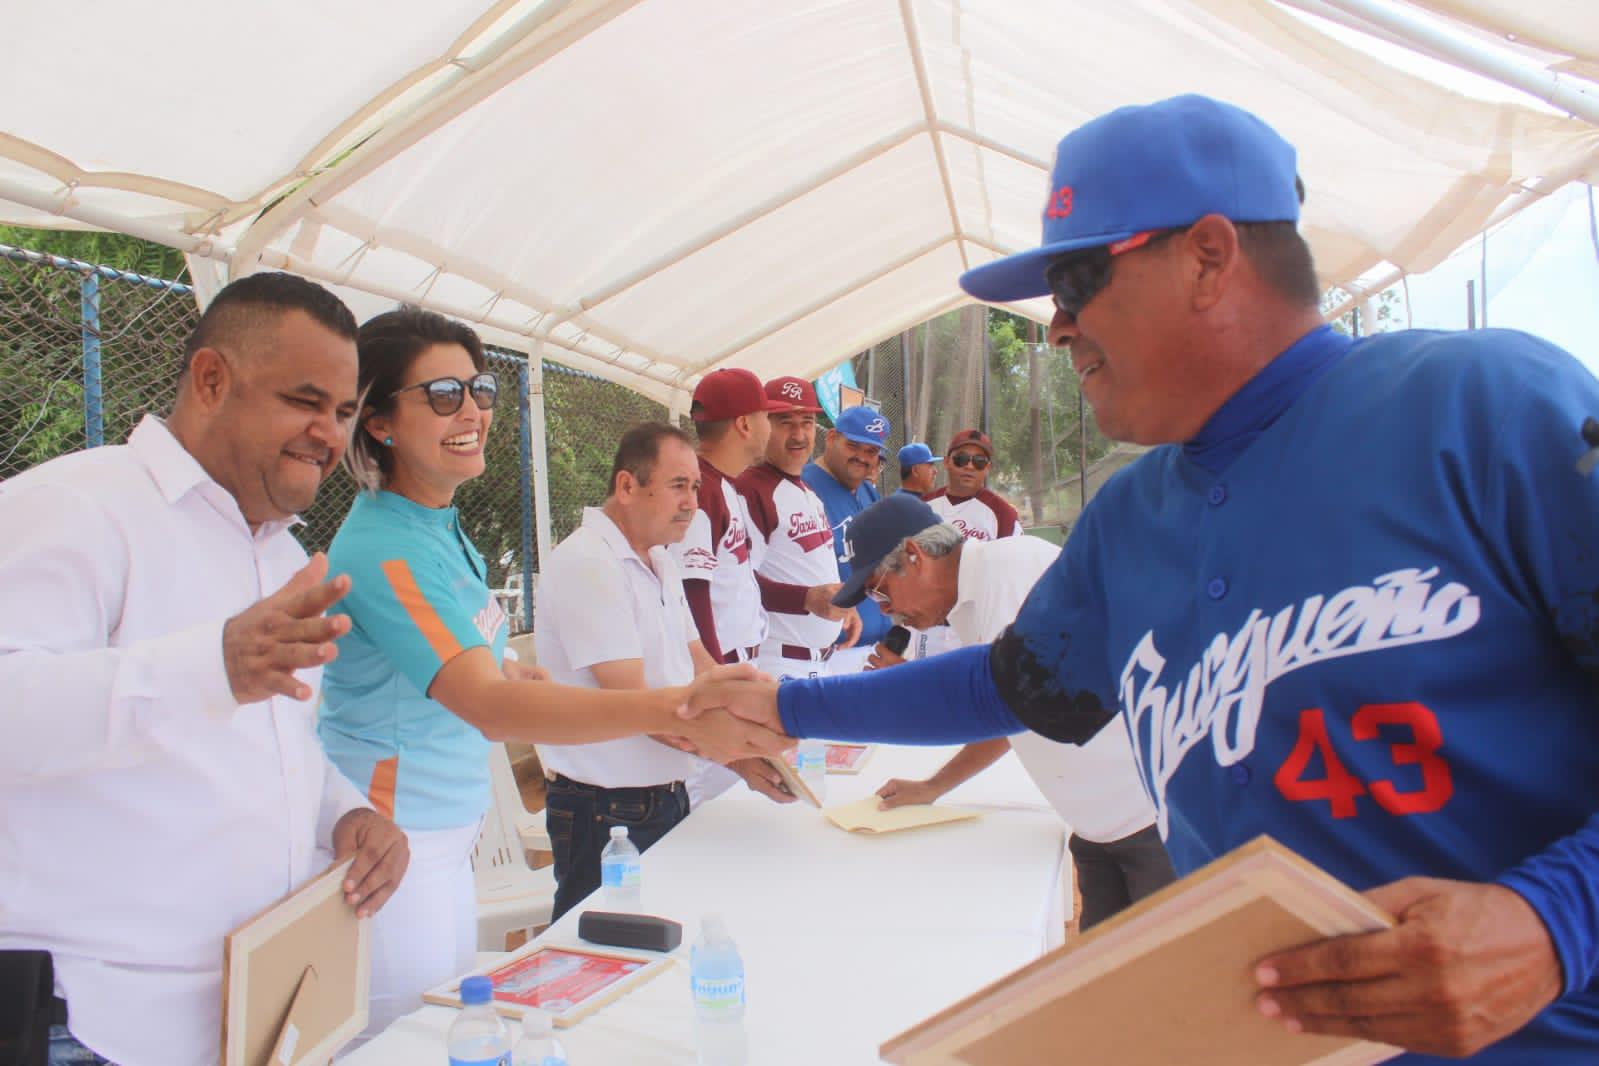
[0,273,408,1066]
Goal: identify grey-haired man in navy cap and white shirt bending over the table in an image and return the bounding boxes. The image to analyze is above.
[835,494,1174,930]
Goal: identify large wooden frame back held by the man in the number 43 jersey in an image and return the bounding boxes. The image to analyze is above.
[881,837,1399,1066]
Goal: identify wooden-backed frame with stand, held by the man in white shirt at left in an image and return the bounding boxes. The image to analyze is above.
[222,860,371,1066]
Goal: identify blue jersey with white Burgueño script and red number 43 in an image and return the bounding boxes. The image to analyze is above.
[991,329,1599,1066]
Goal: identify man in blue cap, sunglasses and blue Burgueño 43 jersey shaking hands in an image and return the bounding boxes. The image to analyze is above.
[696,96,1599,1066]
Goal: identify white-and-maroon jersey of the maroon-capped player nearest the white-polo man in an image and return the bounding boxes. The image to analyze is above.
[672,459,766,654]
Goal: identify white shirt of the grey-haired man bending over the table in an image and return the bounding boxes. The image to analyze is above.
[948,535,1154,844]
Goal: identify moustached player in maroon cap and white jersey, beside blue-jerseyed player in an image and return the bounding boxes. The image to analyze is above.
[736,377,860,678]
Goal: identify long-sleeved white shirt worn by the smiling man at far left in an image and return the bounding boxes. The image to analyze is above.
[0,417,366,1066]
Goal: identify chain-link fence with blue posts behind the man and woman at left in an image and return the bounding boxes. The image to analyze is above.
[0,245,684,631]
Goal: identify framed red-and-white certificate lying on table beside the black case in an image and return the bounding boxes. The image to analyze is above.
[422,945,672,1028]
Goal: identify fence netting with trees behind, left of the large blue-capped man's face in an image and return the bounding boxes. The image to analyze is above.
[854,307,1142,537]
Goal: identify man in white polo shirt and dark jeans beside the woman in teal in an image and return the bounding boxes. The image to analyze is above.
[534,422,732,917]
